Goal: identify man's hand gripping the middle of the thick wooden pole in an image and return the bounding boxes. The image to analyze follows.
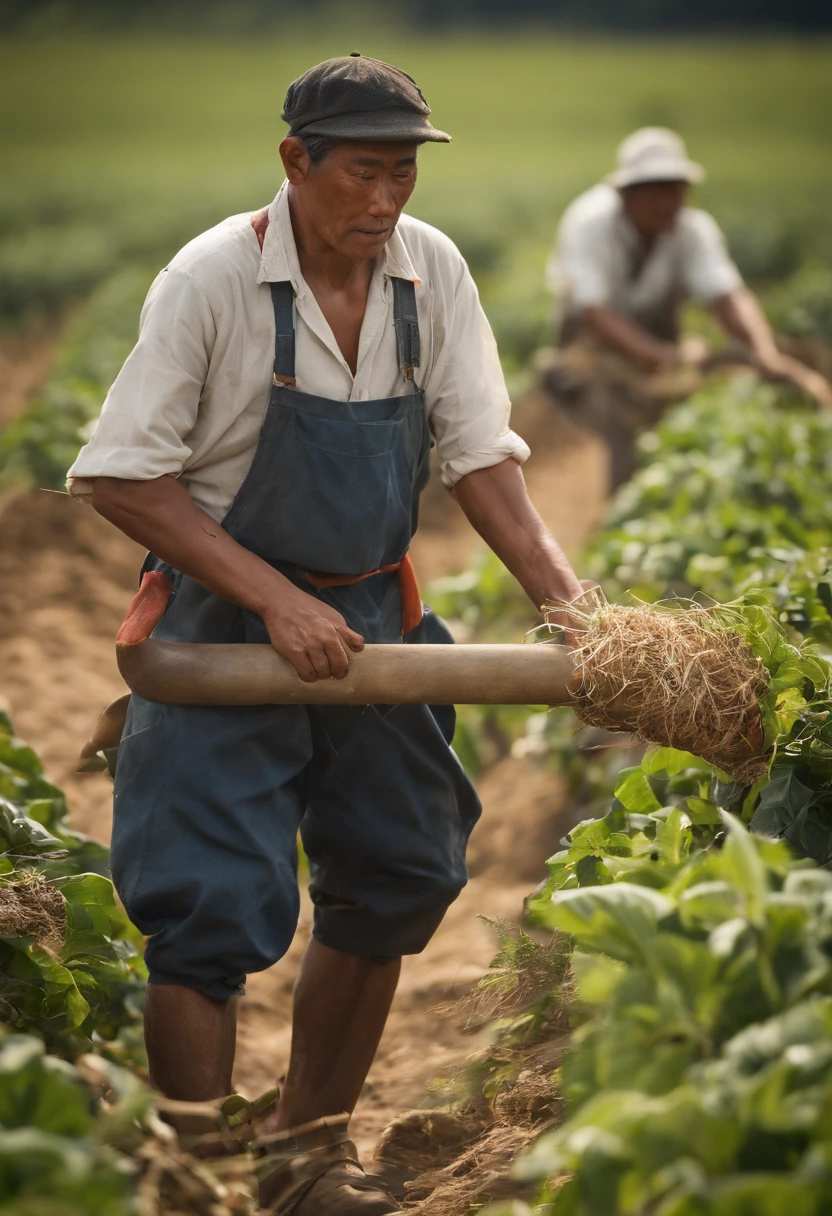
[260,580,364,683]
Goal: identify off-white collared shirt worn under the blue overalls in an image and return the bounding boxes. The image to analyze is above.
[67,185,529,520]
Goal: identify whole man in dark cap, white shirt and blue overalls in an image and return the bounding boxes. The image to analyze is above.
[69,55,581,1216]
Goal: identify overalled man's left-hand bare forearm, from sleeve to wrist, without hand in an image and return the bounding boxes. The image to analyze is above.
[92,477,289,613]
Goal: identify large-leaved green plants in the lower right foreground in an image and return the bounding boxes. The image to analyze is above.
[522,806,832,1216]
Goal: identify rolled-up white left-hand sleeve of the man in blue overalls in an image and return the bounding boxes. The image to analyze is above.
[67,270,215,499]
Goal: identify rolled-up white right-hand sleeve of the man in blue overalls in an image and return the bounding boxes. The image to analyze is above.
[425,250,530,489]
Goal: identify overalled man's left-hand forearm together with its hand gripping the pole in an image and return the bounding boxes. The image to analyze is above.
[92,477,364,683]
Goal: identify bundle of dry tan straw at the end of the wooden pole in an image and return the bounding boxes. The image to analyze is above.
[551,597,769,784]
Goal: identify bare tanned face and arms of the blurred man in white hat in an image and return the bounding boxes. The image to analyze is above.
[581,181,832,406]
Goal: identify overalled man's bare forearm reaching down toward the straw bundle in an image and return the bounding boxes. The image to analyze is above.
[455,460,583,610]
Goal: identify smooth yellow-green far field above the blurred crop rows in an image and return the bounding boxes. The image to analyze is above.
[0,35,832,212]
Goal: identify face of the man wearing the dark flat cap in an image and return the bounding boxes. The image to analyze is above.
[281,139,417,260]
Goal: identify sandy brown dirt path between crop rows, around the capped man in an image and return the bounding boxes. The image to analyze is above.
[0,367,605,1150]
